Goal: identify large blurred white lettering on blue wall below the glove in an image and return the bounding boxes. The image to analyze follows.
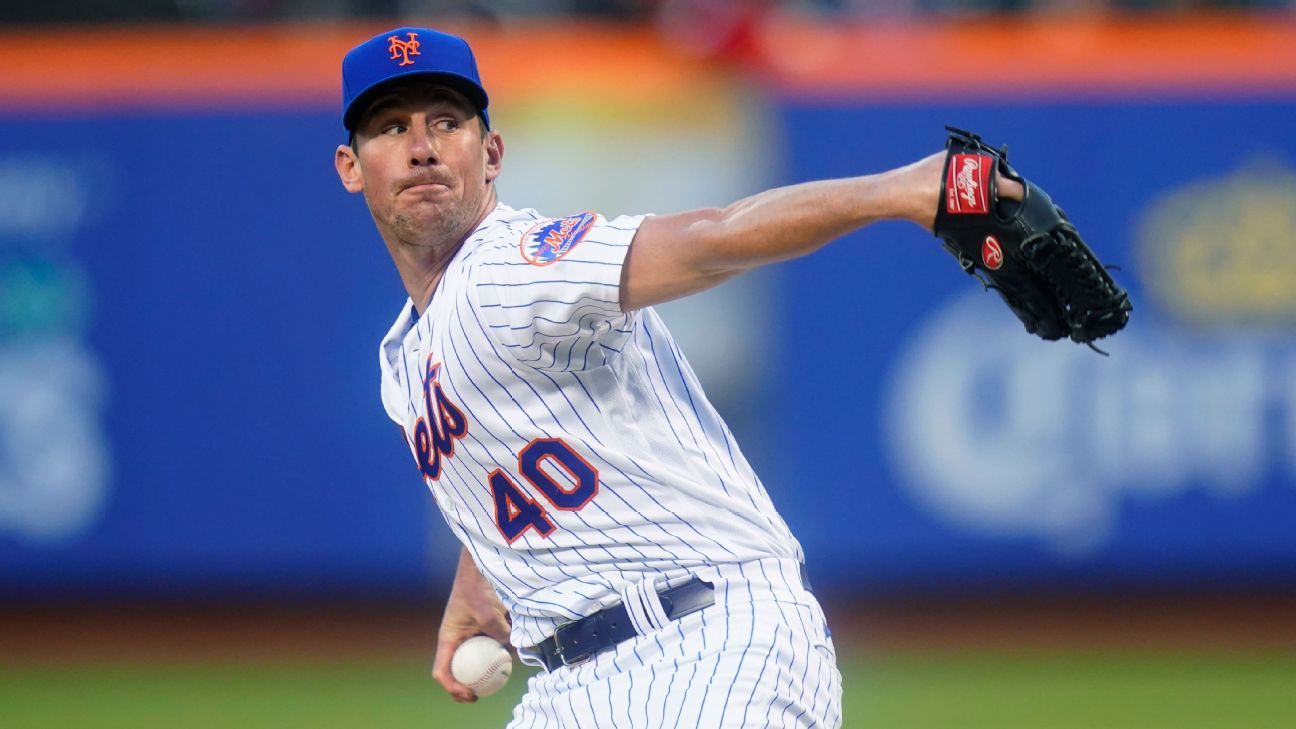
[884,292,1296,554]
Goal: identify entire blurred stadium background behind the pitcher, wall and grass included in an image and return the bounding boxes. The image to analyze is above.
[0,0,1296,729]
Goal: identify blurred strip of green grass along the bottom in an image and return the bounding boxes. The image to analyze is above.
[0,654,1296,729]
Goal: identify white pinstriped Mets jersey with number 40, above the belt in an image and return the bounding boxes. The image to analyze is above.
[380,205,802,646]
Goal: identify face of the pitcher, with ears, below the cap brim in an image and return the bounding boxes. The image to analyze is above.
[336,82,503,246]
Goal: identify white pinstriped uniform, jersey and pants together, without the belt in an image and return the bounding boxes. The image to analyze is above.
[380,205,840,729]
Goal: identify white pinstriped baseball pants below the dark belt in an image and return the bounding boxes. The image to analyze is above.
[508,560,841,729]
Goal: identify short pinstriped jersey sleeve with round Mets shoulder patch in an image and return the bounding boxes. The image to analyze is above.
[473,213,644,371]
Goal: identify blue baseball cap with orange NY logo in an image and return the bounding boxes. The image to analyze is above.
[342,27,490,132]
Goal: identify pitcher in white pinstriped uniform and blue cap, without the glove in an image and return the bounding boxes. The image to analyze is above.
[336,27,1021,729]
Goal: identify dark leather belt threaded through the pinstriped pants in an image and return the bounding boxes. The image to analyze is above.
[529,564,810,671]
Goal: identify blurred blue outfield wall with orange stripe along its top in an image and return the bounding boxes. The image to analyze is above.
[0,18,1296,597]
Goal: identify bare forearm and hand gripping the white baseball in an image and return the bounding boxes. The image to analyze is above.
[432,550,509,703]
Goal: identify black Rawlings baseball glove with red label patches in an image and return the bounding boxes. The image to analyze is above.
[933,127,1133,352]
